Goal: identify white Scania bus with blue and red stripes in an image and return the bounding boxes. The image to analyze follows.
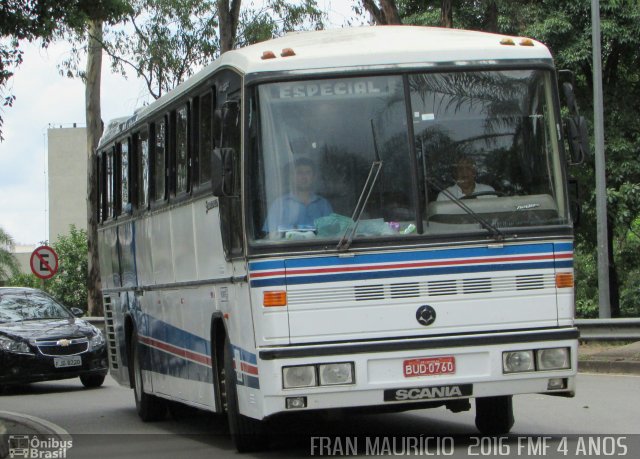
[97,27,578,451]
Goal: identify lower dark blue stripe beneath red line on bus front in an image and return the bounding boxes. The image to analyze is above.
[251,260,560,287]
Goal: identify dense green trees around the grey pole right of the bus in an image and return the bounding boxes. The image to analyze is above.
[397,0,640,317]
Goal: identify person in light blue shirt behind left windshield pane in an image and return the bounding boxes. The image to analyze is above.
[262,158,333,237]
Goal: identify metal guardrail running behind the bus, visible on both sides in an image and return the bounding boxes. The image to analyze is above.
[83,317,640,341]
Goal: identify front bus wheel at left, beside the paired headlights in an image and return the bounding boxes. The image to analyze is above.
[222,338,269,453]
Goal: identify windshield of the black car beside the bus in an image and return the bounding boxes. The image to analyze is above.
[0,291,73,322]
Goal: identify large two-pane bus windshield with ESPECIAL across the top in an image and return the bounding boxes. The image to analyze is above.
[248,69,569,244]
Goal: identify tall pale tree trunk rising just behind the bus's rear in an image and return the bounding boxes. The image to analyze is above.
[85,20,103,316]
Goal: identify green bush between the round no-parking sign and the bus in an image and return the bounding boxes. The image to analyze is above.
[46,225,88,311]
